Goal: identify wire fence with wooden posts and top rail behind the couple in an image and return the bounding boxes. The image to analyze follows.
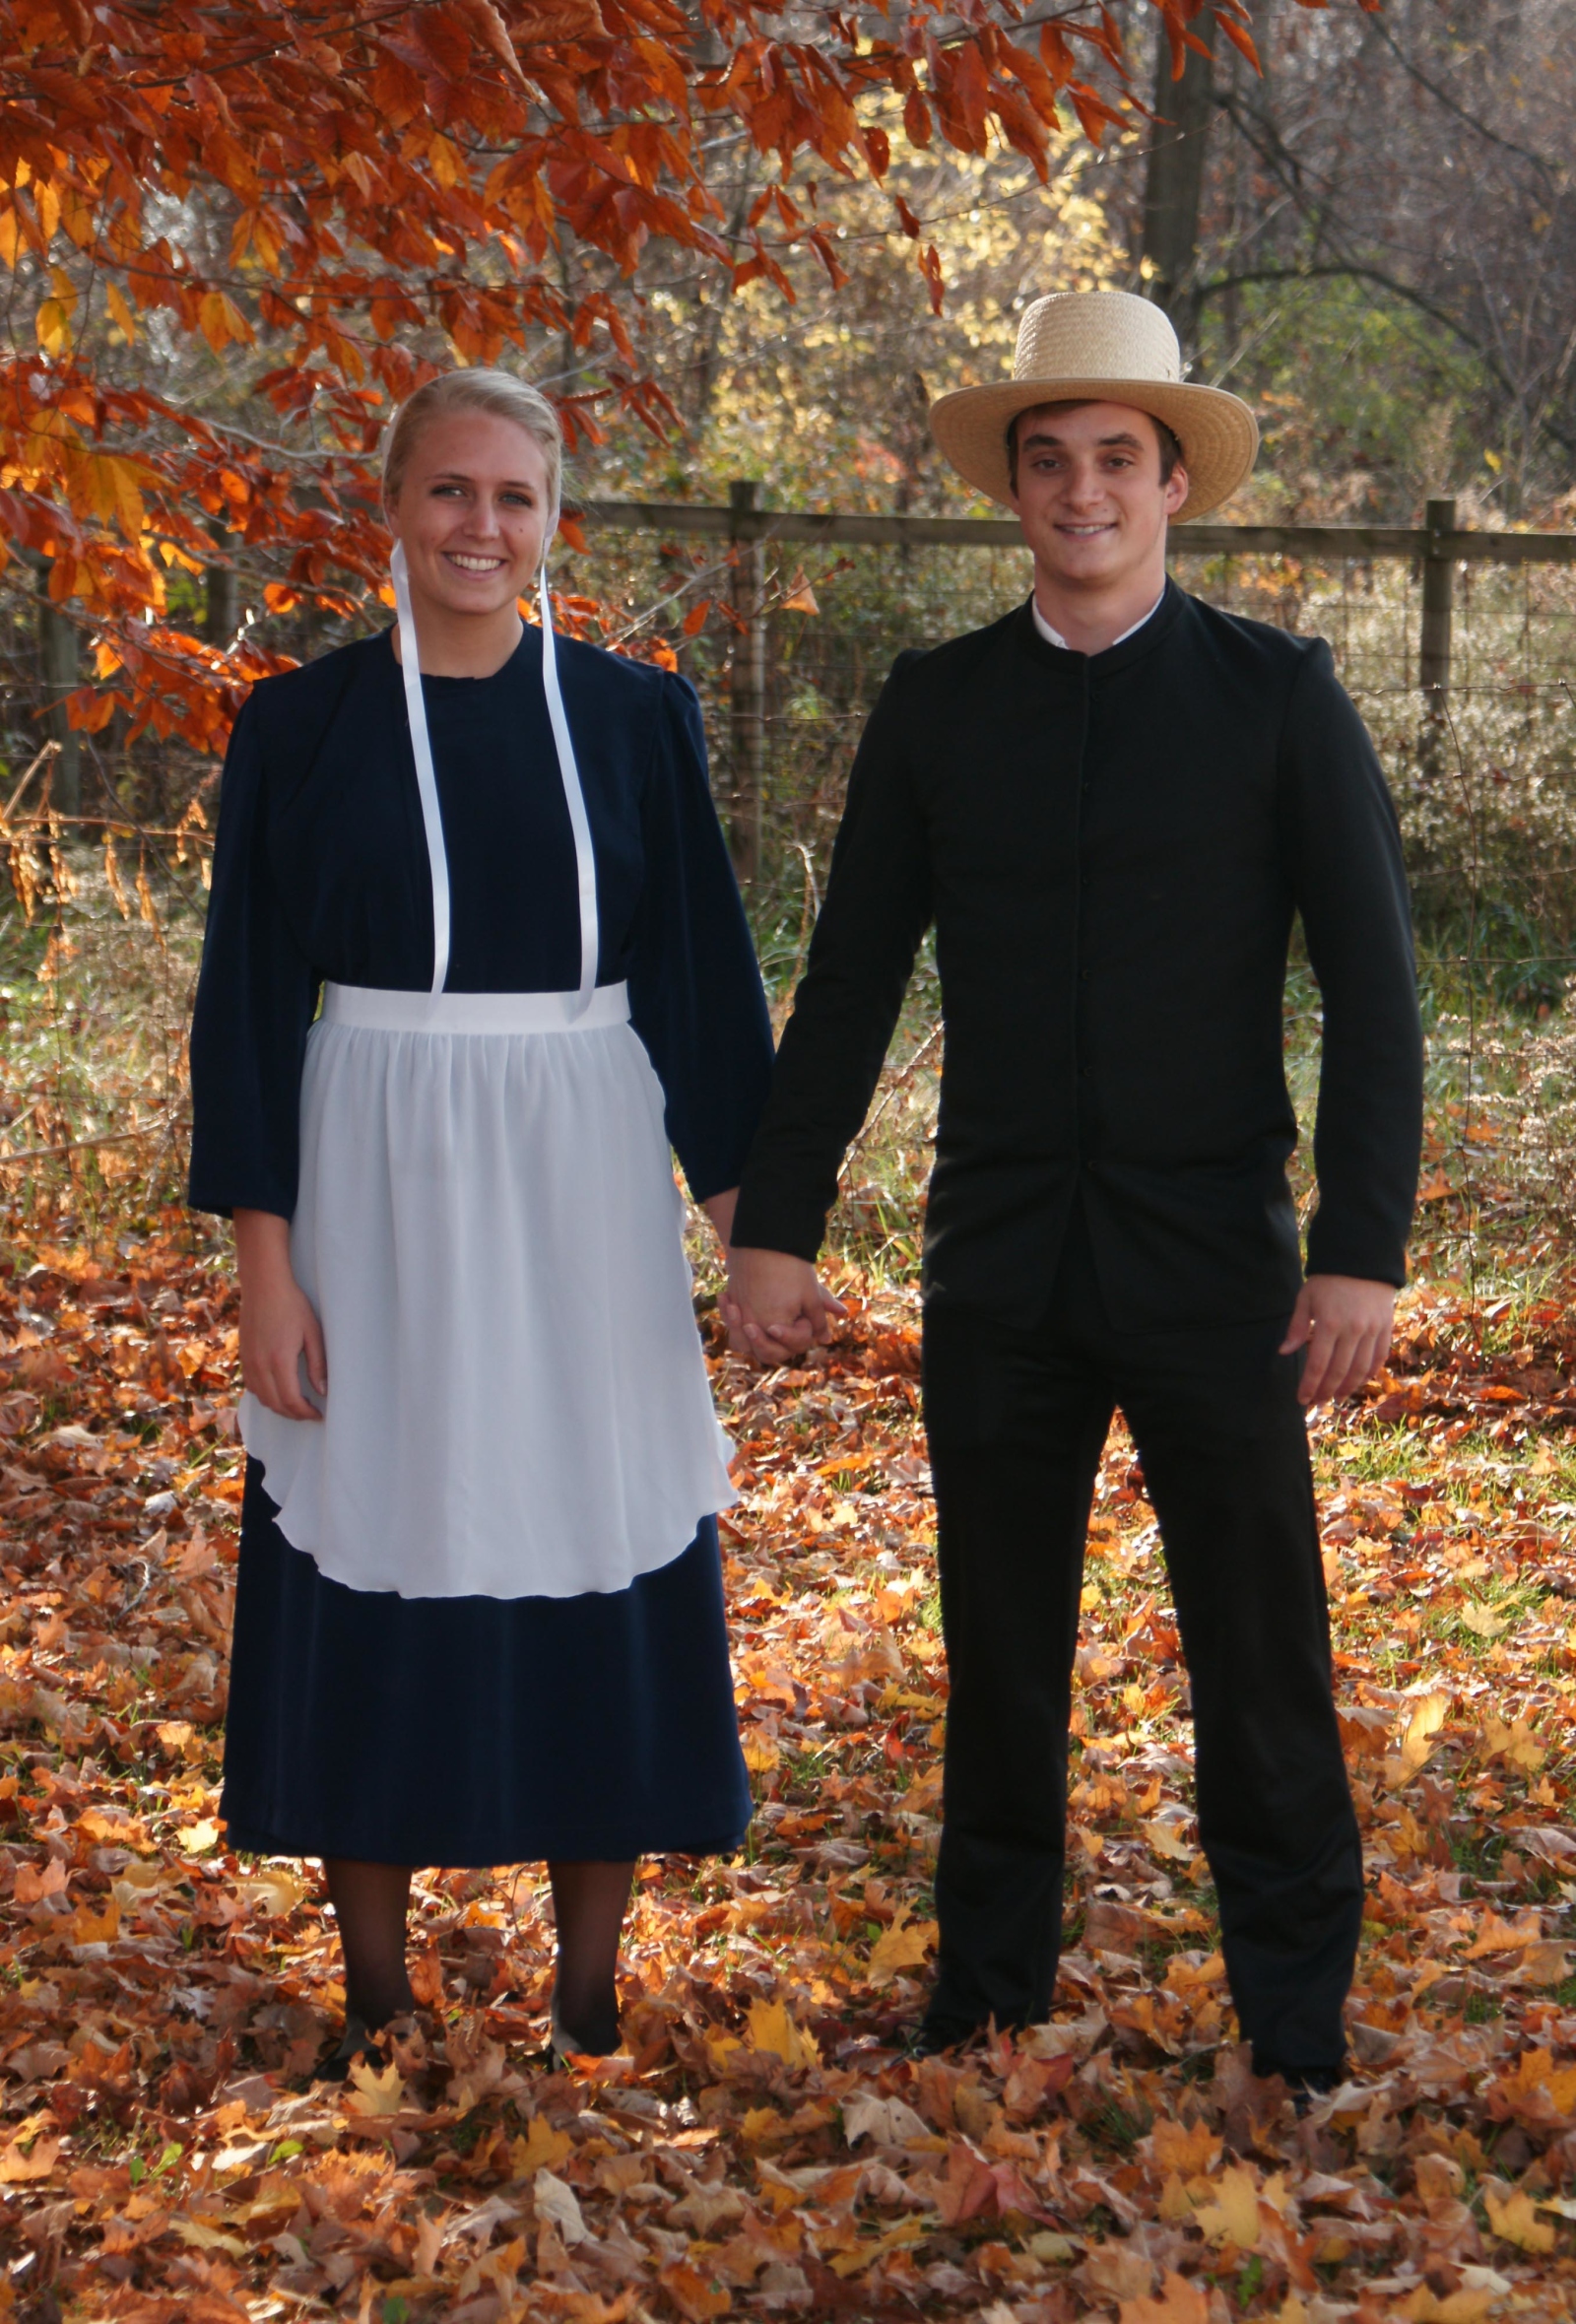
[0,493,1576,1238]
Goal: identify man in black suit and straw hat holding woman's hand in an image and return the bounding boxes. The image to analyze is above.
[728,293,1422,2090]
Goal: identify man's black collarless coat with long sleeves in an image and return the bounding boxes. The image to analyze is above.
[735,583,1422,1329]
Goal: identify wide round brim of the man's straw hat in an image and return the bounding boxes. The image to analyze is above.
[930,379,1258,523]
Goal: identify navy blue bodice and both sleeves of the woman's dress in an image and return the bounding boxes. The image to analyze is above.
[191,628,771,1218]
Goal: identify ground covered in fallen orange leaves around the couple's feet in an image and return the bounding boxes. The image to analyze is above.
[0,1218,1576,2324]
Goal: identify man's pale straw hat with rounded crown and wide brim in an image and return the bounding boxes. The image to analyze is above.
[930,291,1258,518]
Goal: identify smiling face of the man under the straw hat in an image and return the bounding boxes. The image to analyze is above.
[1014,404,1188,588]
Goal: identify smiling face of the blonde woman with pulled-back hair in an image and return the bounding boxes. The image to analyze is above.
[388,412,554,616]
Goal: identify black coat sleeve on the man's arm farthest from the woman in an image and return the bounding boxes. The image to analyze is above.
[1280,643,1422,1286]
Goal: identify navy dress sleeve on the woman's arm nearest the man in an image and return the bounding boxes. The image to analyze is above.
[627,679,771,1202]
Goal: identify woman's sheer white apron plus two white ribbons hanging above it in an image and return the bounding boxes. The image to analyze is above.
[239,549,737,1599]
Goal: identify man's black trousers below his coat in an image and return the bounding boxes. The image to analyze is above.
[925,1211,1362,2076]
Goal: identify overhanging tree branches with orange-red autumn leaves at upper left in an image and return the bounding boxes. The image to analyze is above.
[0,0,1378,785]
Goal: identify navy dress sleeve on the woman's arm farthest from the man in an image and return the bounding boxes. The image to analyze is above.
[191,699,316,1218]
